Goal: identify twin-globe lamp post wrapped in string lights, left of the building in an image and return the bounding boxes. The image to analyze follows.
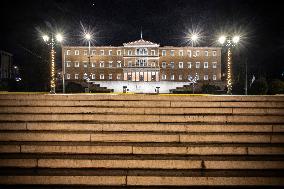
[42,33,63,94]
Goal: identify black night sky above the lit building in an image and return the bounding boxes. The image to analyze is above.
[0,0,284,89]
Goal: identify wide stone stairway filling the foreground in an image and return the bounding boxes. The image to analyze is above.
[0,94,284,188]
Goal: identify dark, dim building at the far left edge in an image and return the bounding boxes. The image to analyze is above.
[0,51,13,81]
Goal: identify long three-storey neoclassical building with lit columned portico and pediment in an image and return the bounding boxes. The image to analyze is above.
[62,37,221,93]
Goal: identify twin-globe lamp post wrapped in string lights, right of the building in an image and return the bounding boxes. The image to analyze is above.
[218,36,240,94]
